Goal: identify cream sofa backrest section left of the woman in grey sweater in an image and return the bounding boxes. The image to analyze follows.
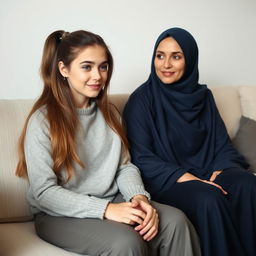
[0,100,33,222]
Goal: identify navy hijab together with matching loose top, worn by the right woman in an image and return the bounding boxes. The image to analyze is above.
[124,28,247,192]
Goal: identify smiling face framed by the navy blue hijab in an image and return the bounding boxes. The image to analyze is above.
[154,37,185,84]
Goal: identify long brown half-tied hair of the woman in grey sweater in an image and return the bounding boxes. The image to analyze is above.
[16,30,128,181]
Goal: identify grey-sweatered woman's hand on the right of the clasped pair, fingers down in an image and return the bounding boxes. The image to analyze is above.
[132,195,159,241]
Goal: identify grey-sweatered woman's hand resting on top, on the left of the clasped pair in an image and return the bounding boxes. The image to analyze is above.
[104,201,146,225]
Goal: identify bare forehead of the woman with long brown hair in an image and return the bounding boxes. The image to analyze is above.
[74,45,107,62]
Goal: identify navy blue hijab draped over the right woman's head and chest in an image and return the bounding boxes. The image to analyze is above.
[146,28,214,174]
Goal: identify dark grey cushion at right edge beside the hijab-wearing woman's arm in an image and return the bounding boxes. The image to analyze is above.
[233,116,256,172]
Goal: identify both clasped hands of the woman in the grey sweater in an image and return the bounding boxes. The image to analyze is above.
[105,195,159,241]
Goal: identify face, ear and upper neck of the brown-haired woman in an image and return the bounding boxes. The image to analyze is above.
[59,45,108,108]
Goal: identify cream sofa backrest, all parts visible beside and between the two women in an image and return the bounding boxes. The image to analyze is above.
[0,87,245,222]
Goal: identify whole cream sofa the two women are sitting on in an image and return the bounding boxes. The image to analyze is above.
[0,86,256,256]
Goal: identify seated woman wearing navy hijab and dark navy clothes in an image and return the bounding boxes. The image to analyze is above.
[124,28,256,256]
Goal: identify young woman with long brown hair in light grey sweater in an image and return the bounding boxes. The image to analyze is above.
[16,31,200,256]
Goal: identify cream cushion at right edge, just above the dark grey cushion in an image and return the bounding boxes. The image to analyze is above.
[238,86,256,120]
